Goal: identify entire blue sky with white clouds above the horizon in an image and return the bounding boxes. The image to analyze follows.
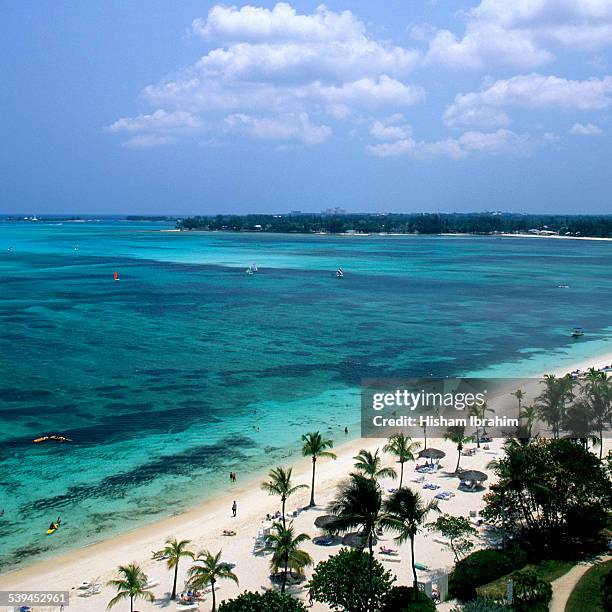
[0,0,612,215]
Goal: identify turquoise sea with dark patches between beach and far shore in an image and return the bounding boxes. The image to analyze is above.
[0,221,612,570]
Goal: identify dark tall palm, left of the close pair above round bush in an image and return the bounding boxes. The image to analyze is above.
[325,474,382,611]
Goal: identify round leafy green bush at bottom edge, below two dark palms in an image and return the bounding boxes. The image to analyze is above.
[308,548,395,612]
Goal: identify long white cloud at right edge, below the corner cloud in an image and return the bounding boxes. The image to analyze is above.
[444,73,612,127]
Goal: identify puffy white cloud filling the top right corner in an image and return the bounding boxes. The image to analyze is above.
[427,0,612,69]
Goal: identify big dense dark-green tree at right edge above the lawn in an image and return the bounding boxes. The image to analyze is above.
[483,438,612,558]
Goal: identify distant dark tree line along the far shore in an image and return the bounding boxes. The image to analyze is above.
[176,213,612,238]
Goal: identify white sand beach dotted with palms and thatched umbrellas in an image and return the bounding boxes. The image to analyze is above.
[0,354,612,612]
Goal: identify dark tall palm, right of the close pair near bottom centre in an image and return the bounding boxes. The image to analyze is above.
[380,487,440,596]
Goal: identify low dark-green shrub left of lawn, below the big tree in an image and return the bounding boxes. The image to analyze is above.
[448,548,525,601]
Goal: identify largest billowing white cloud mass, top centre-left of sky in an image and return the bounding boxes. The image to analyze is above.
[110,2,425,147]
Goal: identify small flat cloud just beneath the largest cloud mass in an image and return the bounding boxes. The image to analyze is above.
[225,113,331,145]
